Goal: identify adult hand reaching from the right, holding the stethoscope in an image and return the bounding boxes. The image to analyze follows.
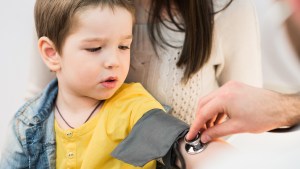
[187,82,300,143]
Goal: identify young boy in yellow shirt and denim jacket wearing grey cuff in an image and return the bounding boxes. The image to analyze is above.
[0,0,230,169]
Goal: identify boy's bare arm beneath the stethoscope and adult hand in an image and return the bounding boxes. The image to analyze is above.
[176,139,235,169]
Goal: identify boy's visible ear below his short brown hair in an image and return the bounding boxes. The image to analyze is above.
[38,36,61,72]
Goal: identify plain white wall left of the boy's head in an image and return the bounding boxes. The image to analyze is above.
[0,0,35,152]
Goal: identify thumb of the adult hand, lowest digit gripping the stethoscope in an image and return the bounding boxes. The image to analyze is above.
[201,120,237,143]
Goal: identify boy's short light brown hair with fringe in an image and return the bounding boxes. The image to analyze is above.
[34,0,134,53]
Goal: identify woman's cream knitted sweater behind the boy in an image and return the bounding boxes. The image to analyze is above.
[27,0,262,123]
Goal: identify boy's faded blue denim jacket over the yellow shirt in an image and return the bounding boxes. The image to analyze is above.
[0,80,58,169]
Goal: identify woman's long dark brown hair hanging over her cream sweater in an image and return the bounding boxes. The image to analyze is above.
[148,0,232,83]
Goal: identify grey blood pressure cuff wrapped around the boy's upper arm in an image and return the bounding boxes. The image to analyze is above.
[111,109,189,167]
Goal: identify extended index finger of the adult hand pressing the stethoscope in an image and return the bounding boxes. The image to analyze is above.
[186,98,224,140]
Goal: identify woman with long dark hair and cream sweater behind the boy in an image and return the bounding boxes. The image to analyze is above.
[27,0,262,129]
